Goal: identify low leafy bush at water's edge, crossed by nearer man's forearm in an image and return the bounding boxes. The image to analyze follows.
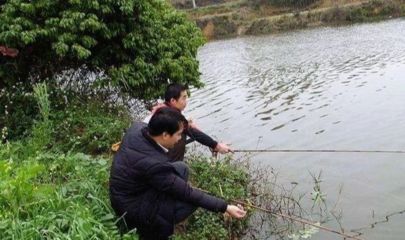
[176,156,250,240]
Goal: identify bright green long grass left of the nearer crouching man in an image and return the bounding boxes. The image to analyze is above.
[0,143,138,240]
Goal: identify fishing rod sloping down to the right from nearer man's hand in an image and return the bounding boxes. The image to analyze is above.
[231,200,364,240]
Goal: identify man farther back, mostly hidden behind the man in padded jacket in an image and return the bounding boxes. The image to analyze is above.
[144,83,232,161]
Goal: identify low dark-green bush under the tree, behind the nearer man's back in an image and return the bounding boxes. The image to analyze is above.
[53,101,131,154]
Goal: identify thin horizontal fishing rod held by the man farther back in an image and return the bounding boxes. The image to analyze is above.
[232,149,405,154]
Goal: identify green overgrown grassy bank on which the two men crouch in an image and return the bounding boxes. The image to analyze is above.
[0,84,250,240]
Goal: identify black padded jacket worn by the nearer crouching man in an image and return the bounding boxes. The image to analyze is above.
[110,122,227,239]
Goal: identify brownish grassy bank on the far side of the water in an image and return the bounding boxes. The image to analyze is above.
[182,0,405,39]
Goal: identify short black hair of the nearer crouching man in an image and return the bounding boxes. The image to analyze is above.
[148,107,187,136]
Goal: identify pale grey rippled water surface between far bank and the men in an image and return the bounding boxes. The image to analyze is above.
[187,20,405,239]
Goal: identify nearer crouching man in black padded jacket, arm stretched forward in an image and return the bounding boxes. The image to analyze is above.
[110,108,246,240]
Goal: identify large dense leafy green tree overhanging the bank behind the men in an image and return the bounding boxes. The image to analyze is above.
[0,0,203,100]
